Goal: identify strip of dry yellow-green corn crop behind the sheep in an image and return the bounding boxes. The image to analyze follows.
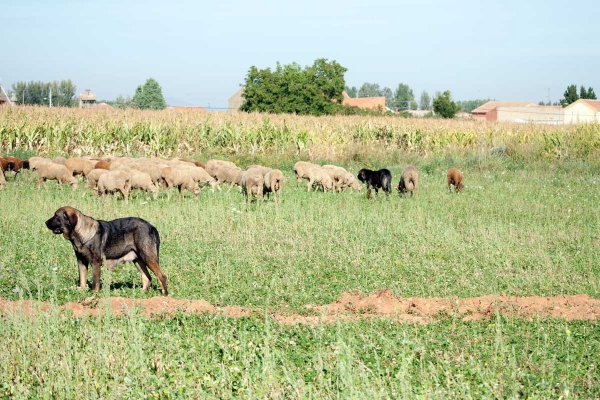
[0,107,600,160]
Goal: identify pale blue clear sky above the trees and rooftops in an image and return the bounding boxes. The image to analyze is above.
[0,0,600,107]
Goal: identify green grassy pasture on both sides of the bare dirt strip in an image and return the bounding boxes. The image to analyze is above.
[0,156,600,398]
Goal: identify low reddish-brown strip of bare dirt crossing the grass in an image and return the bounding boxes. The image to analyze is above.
[0,289,600,325]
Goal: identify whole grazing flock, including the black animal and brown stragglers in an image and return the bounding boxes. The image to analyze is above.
[0,156,463,203]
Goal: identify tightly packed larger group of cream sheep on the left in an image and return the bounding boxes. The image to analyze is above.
[0,156,284,203]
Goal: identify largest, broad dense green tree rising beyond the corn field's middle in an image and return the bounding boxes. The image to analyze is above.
[240,58,346,115]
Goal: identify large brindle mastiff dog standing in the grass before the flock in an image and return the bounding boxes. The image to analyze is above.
[46,206,168,296]
